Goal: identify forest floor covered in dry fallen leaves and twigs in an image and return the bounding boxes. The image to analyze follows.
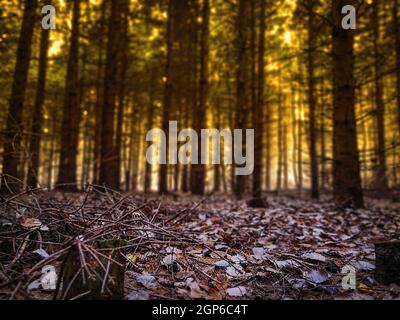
[0,191,400,300]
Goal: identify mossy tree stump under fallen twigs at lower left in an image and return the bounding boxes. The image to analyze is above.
[56,240,126,300]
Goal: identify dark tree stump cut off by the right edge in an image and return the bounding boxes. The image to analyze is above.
[375,241,400,285]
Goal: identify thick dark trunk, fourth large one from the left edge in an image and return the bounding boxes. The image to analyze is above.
[100,1,122,189]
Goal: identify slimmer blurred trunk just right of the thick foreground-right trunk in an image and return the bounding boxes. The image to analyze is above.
[372,0,388,190]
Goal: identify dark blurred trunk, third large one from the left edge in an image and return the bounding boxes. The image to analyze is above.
[57,0,81,191]
